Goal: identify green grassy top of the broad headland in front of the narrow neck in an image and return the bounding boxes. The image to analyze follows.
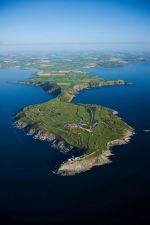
[19,99,129,153]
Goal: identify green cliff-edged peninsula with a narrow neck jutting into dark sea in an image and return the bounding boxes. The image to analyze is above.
[15,67,133,175]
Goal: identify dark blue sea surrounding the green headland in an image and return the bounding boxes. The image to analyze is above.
[0,62,150,225]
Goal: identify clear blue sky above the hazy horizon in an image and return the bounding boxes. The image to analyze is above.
[0,0,150,44]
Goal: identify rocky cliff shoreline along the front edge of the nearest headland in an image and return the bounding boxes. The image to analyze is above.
[14,118,135,176]
